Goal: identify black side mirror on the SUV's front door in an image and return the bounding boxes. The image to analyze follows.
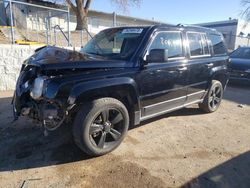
[146,49,168,63]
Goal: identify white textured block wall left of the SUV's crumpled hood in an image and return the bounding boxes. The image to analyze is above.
[0,44,79,91]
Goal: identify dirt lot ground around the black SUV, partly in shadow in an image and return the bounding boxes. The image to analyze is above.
[0,86,250,188]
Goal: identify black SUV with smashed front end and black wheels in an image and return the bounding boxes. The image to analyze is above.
[13,25,229,156]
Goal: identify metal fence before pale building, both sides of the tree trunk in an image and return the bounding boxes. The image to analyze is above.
[0,0,160,47]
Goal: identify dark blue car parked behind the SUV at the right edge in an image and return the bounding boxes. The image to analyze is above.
[230,47,250,84]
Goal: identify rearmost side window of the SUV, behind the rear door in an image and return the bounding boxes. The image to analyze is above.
[209,34,227,55]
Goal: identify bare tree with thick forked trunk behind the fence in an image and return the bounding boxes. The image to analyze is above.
[65,0,142,30]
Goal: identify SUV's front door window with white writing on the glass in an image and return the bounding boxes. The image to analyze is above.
[148,32,184,58]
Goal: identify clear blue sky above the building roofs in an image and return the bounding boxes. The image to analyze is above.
[90,0,243,24]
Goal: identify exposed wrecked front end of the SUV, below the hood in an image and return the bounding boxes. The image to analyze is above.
[13,67,66,131]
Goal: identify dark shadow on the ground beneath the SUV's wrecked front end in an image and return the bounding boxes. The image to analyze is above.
[0,98,89,171]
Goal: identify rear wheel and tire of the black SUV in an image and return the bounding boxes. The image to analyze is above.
[199,80,223,113]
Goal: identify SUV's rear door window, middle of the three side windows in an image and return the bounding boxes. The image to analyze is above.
[187,33,210,56]
